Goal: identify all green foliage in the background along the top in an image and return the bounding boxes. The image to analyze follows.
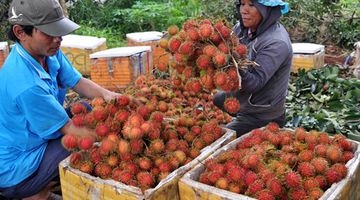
[0,0,360,48]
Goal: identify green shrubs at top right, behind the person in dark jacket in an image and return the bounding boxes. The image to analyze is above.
[282,0,360,47]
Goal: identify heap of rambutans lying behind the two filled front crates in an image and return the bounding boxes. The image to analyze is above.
[124,75,232,124]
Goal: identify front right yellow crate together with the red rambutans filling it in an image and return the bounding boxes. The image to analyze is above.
[179,123,360,200]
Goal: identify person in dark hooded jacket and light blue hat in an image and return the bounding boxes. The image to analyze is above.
[214,0,292,136]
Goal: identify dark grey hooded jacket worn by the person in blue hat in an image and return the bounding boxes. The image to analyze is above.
[234,1,292,120]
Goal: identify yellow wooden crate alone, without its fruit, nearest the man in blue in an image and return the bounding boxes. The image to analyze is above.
[59,129,236,200]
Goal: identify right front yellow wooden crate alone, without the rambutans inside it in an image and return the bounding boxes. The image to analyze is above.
[179,129,360,200]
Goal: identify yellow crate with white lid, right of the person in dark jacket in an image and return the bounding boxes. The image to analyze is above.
[292,43,325,73]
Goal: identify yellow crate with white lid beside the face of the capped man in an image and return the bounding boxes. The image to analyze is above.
[61,34,107,76]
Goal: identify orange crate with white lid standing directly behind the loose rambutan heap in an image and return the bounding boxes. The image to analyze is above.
[90,46,152,91]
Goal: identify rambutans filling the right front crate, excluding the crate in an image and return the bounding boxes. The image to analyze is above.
[195,123,354,200]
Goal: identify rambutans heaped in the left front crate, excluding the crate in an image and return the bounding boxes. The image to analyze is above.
[62,95,225,191]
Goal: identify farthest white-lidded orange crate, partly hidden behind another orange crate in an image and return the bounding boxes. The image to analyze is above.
[126,31,170,66]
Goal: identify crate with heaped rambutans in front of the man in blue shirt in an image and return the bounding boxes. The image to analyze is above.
[59,95,235,199]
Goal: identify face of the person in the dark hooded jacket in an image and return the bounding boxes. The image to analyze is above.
[240,0,262,32]
